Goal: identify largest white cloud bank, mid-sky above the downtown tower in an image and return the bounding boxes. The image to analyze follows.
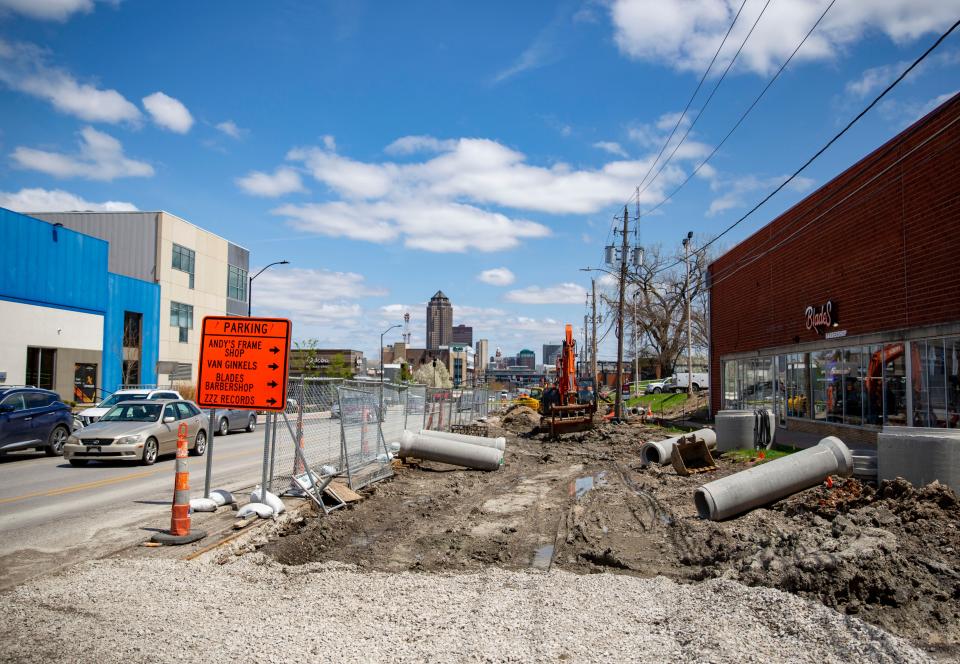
[258,126,706,252]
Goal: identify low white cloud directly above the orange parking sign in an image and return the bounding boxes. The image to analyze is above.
[252,267,387,329]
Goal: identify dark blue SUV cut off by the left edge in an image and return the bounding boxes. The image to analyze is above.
[0,386,73,456]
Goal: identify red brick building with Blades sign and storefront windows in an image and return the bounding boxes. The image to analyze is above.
[709,95,960,442]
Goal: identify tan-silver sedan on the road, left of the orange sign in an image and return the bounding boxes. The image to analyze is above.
[63,399,207,466]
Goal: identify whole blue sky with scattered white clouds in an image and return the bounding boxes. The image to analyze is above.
[0,0,960,361]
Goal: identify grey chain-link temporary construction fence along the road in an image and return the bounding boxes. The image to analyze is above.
[263,377,489,498]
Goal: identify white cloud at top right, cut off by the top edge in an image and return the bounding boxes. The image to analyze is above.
[609,0,960,74]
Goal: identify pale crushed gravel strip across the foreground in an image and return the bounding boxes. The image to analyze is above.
[0,553,929,664]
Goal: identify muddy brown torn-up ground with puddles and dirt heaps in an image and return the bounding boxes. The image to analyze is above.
[266,420,960,657]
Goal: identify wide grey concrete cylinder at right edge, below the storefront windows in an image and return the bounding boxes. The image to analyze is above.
[877,427,960,491]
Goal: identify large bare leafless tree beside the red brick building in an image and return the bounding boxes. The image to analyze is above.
[603,245,708,377]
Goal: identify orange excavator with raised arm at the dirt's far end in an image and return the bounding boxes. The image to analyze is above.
[540,325,597,438]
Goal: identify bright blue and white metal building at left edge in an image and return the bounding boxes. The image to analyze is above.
[0,208,160,401]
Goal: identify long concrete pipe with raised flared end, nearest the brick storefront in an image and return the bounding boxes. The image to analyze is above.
[693,436,853,521]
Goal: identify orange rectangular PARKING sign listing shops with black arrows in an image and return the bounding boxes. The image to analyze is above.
[197,316,291,411]
